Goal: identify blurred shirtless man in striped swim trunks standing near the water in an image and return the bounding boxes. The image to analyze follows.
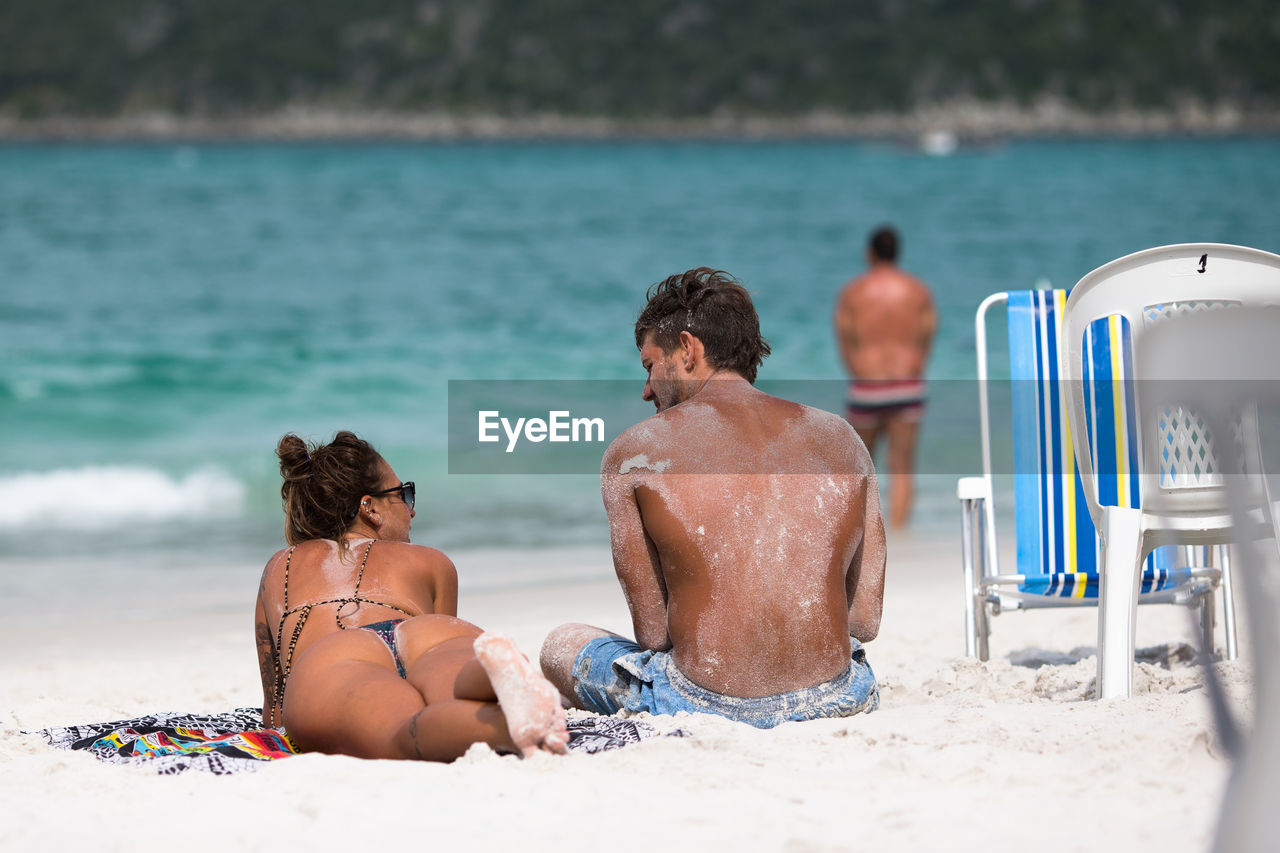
[835,228,938,529]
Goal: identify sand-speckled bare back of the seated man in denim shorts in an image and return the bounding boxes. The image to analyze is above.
[602,379,882,697]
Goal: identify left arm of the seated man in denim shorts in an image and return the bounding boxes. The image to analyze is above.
[600,442,671,651]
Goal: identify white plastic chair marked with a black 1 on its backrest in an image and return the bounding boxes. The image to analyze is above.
[1062,243,1280,699]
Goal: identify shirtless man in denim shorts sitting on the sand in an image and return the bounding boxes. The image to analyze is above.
[541,268,884,727]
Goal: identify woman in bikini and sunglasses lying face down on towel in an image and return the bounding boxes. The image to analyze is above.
[255,432,568,761]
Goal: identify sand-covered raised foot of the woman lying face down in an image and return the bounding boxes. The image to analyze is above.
[475,633,568,757]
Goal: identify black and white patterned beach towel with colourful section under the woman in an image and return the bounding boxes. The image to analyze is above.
[23,708,687,775]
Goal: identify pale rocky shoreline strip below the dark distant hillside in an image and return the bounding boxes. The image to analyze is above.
[0,100,1280,142]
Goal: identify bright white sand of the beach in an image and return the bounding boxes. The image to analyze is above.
[0,538,1248,852]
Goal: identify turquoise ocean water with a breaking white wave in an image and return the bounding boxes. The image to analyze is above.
[0,138,1280,593]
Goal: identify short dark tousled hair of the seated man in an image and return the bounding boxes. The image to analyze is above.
[636,266,769,384]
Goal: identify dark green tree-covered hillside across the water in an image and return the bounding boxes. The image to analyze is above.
[0,0,1280,118]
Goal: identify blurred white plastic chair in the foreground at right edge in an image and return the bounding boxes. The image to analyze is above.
[1134,306,1280,853]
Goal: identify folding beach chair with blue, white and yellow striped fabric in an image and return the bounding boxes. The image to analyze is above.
[957,289,1220,660]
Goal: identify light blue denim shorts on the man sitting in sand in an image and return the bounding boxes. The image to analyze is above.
[573,635,879,729]
